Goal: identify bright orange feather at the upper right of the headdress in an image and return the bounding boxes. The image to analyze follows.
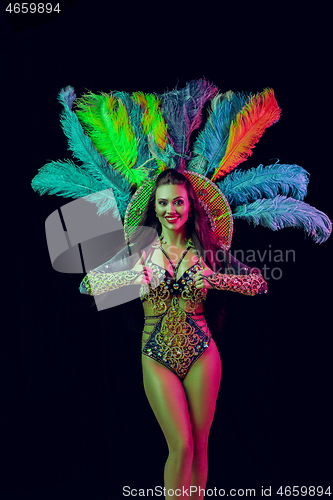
[211,89,281,182]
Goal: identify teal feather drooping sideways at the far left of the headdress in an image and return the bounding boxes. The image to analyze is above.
[31,160,119,218]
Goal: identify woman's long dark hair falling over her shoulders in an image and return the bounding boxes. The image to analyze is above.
[131,169,221,271]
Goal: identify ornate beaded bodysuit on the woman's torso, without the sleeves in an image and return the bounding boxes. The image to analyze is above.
[141,242,211,379]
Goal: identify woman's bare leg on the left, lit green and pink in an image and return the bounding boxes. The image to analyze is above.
[142,355,193,499]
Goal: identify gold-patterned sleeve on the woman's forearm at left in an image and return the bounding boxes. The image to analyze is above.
[82,271,142,295]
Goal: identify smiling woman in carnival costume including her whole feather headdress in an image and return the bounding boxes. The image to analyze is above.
[32,79,332,498]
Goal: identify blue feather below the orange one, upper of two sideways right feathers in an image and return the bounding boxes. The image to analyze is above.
[217,162,310,206]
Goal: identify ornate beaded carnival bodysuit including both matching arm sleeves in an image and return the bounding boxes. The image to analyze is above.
[80,240,267,379]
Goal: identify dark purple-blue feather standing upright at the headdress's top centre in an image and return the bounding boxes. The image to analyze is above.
[160,79,218,171]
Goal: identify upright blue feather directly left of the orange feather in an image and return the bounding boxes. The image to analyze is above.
[188,91,250,176]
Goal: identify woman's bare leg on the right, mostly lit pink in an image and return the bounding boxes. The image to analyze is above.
[183,340,221,500]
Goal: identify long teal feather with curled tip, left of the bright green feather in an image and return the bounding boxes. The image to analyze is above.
[55,86,132,217]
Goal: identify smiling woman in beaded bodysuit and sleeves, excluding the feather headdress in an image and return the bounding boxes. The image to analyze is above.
[81,169,267,499]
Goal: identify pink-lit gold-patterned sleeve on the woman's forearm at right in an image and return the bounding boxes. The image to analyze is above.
[205,274,268,295]
